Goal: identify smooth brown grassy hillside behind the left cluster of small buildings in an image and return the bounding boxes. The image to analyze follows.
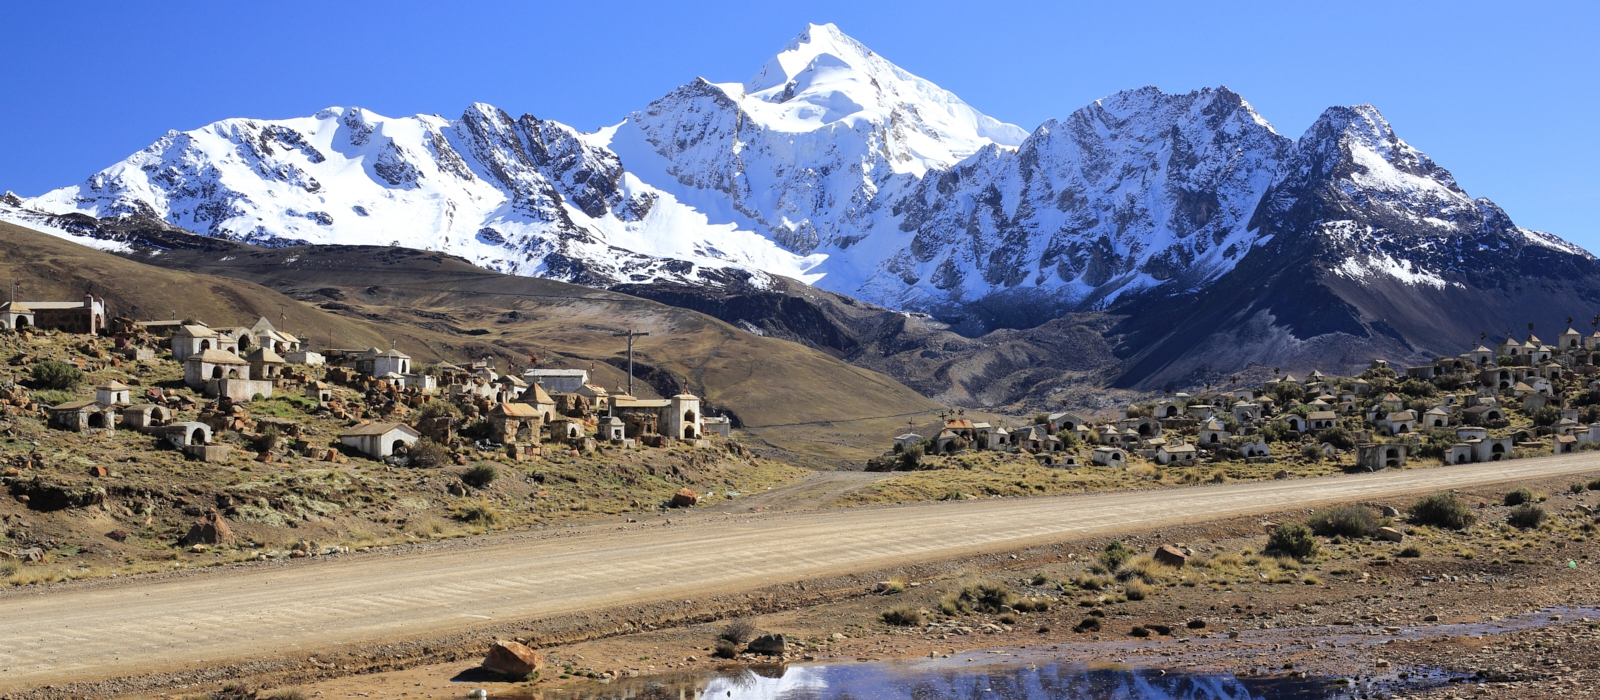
[0,225,938,444]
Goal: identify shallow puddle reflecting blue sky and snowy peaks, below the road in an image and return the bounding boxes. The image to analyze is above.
[531,662,1352,700]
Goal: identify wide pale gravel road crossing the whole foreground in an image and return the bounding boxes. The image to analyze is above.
[0,452,1600,690]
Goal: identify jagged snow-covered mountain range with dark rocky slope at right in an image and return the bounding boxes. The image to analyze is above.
[15,24,1600,393]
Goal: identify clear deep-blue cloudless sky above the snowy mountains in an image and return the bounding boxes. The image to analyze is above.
[0,0,1600,251]
